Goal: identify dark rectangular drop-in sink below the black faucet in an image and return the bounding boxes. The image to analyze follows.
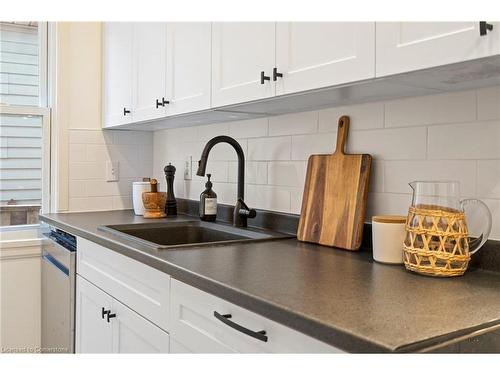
[99,220,292,249]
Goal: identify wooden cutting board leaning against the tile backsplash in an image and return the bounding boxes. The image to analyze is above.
[297,116,372,250]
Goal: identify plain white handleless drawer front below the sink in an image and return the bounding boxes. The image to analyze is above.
[76,237,170,331]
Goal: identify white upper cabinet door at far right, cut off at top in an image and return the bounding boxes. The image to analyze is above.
[376,22,500,77]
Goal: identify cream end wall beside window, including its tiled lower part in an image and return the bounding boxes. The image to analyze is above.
[53,22,153,211]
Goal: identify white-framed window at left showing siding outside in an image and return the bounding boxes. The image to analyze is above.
[0,22,50,226]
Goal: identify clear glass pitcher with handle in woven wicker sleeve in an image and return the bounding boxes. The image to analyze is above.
[403,181,491,277]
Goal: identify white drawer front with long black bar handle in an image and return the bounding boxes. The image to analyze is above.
[170,279,341,353]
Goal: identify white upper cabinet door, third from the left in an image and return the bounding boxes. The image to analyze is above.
[166,22,212,115]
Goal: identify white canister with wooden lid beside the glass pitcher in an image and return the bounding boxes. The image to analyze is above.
[372,215,406,264]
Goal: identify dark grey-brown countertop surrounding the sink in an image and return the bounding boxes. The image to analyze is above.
[41,210,500,352]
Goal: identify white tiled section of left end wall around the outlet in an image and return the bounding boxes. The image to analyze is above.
[69,129,153,211]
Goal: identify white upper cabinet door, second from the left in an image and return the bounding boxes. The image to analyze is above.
[133,22,166,122]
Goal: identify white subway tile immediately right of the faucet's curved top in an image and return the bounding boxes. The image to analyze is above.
[248,137,291,160]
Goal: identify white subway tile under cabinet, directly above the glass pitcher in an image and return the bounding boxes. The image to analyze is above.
[385,91,476,127]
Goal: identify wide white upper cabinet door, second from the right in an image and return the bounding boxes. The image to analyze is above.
[278,22,375,95]
